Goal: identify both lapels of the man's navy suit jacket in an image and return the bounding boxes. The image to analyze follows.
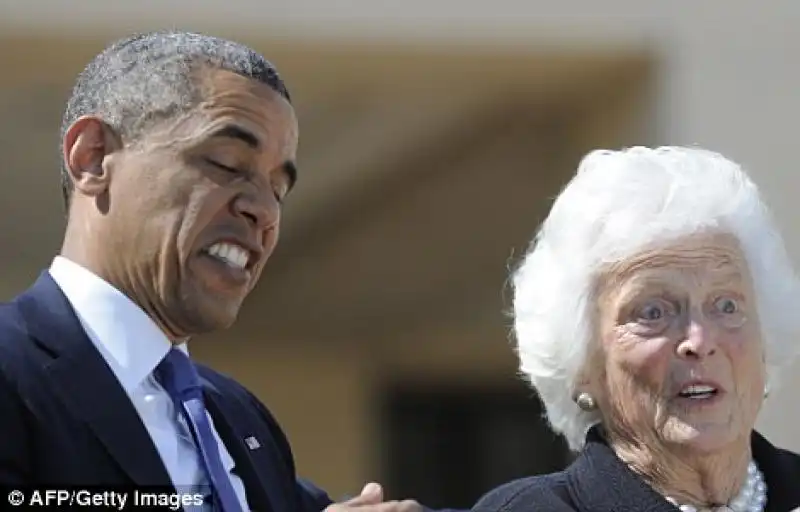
[15,272,292,512]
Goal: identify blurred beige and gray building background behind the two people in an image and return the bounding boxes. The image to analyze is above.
[0,0,800,506]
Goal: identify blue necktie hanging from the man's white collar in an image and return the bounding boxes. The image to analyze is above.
[154,348,242,512]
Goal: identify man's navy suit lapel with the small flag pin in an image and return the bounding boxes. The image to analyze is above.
[203,379,293,512]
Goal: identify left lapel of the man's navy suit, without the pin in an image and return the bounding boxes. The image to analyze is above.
[17,272,171,485]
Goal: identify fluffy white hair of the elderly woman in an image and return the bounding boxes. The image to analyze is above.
[513,147,800,450]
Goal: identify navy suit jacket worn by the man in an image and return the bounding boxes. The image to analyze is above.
[0,273,344,512]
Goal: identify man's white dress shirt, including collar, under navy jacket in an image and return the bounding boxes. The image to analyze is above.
[50,256,249,510]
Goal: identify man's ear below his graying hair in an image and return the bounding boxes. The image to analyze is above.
[63,116,121,197]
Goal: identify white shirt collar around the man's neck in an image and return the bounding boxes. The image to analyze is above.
[50,256,186,395]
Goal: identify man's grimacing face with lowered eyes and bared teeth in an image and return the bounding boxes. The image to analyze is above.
[96,70,298,335]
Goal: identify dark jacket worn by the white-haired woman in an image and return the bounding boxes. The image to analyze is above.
[472,427,800,512]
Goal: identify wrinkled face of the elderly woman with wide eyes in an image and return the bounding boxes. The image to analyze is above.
[593,234,765,451]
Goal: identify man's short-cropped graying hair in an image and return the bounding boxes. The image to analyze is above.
[61,31,291,207]
